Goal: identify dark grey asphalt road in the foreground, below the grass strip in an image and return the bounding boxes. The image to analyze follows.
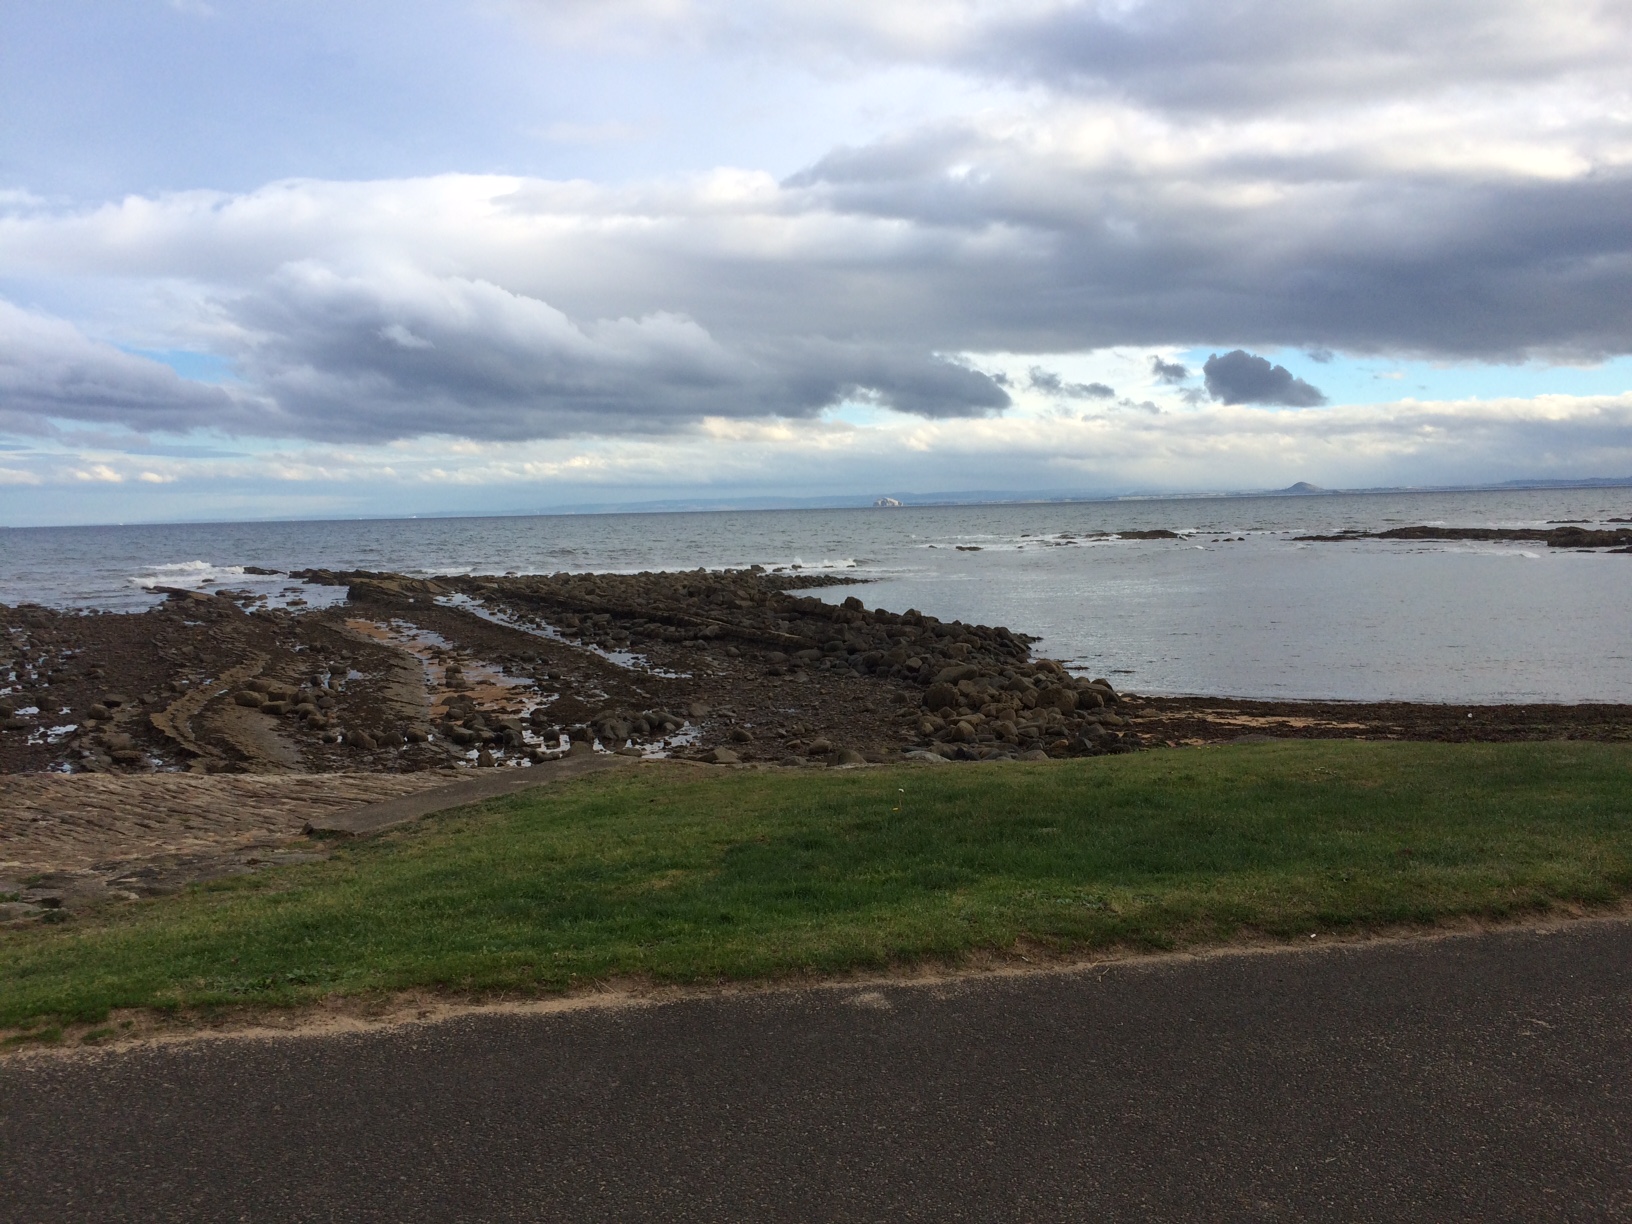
[0,922,1632,1224]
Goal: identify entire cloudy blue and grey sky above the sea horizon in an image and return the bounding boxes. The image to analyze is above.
[0,0,1632,526]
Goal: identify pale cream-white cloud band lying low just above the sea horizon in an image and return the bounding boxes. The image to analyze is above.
[0,393,1632,522]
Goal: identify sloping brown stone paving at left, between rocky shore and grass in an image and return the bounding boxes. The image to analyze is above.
[0,770,455,876]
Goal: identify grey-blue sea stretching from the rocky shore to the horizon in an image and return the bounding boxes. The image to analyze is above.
[0,488,1632,703]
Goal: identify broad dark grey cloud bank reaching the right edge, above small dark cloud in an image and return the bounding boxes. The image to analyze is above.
[798,126,1632,361]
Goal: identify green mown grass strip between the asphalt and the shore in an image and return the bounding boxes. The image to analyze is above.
[0,741,1632,1031]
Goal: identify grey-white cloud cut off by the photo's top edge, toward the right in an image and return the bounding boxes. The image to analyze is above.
[511,0,1632,111]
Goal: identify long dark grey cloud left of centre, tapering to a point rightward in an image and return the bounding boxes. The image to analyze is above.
[212,264,1009,441]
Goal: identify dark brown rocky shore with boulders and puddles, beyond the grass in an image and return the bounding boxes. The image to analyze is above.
[0,570,1632,786]
